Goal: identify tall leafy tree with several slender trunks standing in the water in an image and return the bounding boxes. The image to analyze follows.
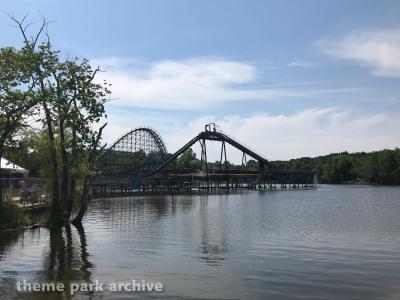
[5,16,110,226]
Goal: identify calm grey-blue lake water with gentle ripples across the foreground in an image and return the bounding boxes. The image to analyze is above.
[0,186,400,300]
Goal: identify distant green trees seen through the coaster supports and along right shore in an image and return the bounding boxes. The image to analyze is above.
[176,148,400,185]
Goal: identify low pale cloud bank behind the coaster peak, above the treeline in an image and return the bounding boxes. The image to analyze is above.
[103,107,400,162]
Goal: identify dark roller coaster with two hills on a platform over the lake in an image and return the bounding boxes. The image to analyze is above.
[93,123,317,193]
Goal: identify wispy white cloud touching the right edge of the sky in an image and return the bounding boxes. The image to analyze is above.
[318,28,400,77]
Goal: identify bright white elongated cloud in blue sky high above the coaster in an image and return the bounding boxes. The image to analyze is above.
[92,57,346,110]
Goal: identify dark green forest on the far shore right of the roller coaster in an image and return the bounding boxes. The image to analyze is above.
[274,148,400,185]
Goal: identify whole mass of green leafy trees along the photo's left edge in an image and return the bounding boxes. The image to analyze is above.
[0,15,110,223]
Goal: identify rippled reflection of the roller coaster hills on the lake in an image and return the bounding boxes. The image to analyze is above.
[93,194,229,266]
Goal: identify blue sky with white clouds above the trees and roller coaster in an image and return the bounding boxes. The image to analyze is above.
[0,0,400,161]
